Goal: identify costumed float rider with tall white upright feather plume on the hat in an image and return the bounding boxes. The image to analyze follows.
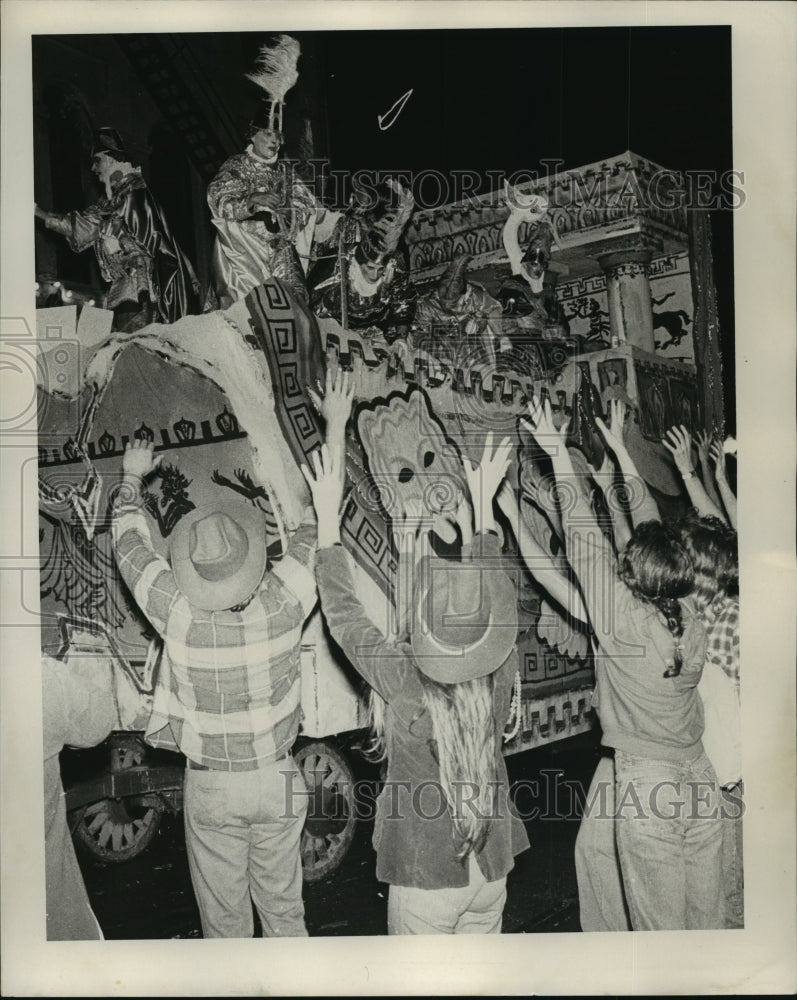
[207,35,338,309]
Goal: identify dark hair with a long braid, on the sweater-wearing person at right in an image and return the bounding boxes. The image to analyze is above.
[620,521,695,677]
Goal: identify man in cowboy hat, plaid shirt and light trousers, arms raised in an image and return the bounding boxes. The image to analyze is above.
[113,376,351,937]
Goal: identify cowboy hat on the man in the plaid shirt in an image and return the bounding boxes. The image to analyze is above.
[169,500,266,611]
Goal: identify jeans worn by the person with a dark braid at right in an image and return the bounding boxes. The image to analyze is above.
[614,750,724,931]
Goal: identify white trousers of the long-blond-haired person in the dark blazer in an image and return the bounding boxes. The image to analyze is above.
[387,854,506,934]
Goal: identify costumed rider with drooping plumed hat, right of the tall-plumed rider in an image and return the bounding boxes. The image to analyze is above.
[310,178,417,345]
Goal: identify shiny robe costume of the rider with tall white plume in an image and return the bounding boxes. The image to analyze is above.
[207,146,318,309]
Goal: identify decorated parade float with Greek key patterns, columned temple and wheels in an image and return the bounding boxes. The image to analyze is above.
[37,153,723,880]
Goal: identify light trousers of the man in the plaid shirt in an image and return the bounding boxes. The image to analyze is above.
[184,758,307,938]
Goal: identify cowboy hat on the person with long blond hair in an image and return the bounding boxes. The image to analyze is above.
[410,556,517,684]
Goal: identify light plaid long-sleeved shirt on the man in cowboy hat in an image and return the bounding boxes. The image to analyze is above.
[113,507,316,771]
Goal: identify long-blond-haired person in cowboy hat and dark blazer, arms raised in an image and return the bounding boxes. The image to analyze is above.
[304,435,528,934]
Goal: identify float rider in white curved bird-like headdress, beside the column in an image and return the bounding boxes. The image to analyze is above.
[497,187,570,366]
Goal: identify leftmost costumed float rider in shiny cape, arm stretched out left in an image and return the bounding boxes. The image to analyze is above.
[34,128,199,333]
